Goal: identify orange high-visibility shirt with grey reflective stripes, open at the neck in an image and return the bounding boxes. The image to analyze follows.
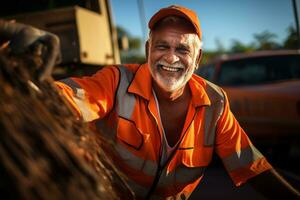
[57,64,271,199]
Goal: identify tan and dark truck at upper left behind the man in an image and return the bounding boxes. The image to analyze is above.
[0,0,120,79]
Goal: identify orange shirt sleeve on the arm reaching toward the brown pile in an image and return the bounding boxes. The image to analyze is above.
[55,66,119,122]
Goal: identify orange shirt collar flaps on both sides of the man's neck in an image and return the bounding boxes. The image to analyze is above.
[128,63,210,107]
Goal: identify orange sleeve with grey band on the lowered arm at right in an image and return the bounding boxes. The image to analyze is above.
[216,90,272,186]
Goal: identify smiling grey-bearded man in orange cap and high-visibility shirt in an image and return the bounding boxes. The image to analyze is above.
[57,6,299,199]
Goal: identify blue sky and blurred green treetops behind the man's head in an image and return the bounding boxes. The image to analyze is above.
[111,0,299,64]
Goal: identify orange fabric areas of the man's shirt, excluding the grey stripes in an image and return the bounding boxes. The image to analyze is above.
[54,64,269,196]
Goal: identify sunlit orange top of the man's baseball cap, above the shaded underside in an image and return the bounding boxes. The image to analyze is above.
[148,5,202,40]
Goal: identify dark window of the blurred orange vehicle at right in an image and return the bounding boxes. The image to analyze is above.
[217,55,300,85]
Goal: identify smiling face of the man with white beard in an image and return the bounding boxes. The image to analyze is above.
[148,24,200,92]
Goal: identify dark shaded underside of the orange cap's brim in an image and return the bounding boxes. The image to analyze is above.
[150,15,197,34]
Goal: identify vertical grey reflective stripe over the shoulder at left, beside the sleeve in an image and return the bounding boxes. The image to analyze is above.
[117,66,135,119]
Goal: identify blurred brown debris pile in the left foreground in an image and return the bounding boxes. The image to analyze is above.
[0,50,133,199]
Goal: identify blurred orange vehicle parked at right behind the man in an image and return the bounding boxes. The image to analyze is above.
[196,50,300,155]
